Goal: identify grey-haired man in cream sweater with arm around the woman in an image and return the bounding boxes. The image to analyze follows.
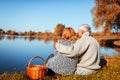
[56,24,101,75]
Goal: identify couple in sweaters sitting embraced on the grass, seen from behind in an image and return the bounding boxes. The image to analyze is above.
[46,24,101,75]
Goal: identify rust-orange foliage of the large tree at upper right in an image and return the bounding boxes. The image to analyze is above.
[91,0,120,32]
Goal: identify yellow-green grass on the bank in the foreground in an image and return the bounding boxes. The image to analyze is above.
[0,55,120,80]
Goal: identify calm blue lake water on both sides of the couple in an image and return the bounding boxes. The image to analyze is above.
[0,36,119,73]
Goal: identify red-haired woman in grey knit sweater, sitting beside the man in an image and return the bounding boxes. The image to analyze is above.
[47,27,78,75]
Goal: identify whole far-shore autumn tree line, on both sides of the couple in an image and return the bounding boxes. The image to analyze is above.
[0,24,120,37]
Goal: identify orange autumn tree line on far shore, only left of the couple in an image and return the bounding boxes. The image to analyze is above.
[0,24,65,36]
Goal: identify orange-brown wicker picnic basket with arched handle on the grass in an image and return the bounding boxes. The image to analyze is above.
[27,56,47,79]
